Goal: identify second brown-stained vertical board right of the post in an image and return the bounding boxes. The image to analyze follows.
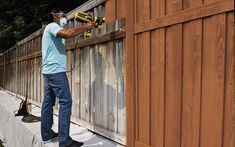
[150,0,165,147]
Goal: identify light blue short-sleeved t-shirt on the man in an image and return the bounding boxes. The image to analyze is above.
[42,22,66,74]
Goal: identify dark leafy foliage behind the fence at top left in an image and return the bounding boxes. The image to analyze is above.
[0,0,87,52]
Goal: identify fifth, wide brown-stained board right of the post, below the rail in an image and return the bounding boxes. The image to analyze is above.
[200,14,226,147]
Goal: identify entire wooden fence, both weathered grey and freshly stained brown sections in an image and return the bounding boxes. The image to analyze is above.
[0,0,235,147]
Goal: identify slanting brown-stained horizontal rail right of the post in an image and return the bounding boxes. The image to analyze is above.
[134,0,234,33]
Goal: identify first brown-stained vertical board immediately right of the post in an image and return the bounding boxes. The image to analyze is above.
[136,0,150,145]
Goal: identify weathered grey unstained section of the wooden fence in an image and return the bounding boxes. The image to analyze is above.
[0,0,126,144]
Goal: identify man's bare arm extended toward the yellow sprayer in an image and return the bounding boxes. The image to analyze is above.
[56,22,96,39]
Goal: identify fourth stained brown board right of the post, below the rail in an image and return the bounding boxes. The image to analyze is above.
[181,20,202,147]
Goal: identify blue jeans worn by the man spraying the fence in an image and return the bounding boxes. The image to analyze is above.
[41,72,73,147]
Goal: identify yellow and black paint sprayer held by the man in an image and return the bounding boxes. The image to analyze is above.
[74,12,105,37]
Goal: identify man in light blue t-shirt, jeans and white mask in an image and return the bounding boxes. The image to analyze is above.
[41,9,95,147]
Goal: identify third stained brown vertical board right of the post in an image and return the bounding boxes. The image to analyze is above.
[165,0,182,147]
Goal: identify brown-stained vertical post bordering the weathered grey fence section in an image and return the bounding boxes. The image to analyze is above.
[125,0,136,147]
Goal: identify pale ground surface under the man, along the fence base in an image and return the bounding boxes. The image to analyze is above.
[0,90,121,147]
